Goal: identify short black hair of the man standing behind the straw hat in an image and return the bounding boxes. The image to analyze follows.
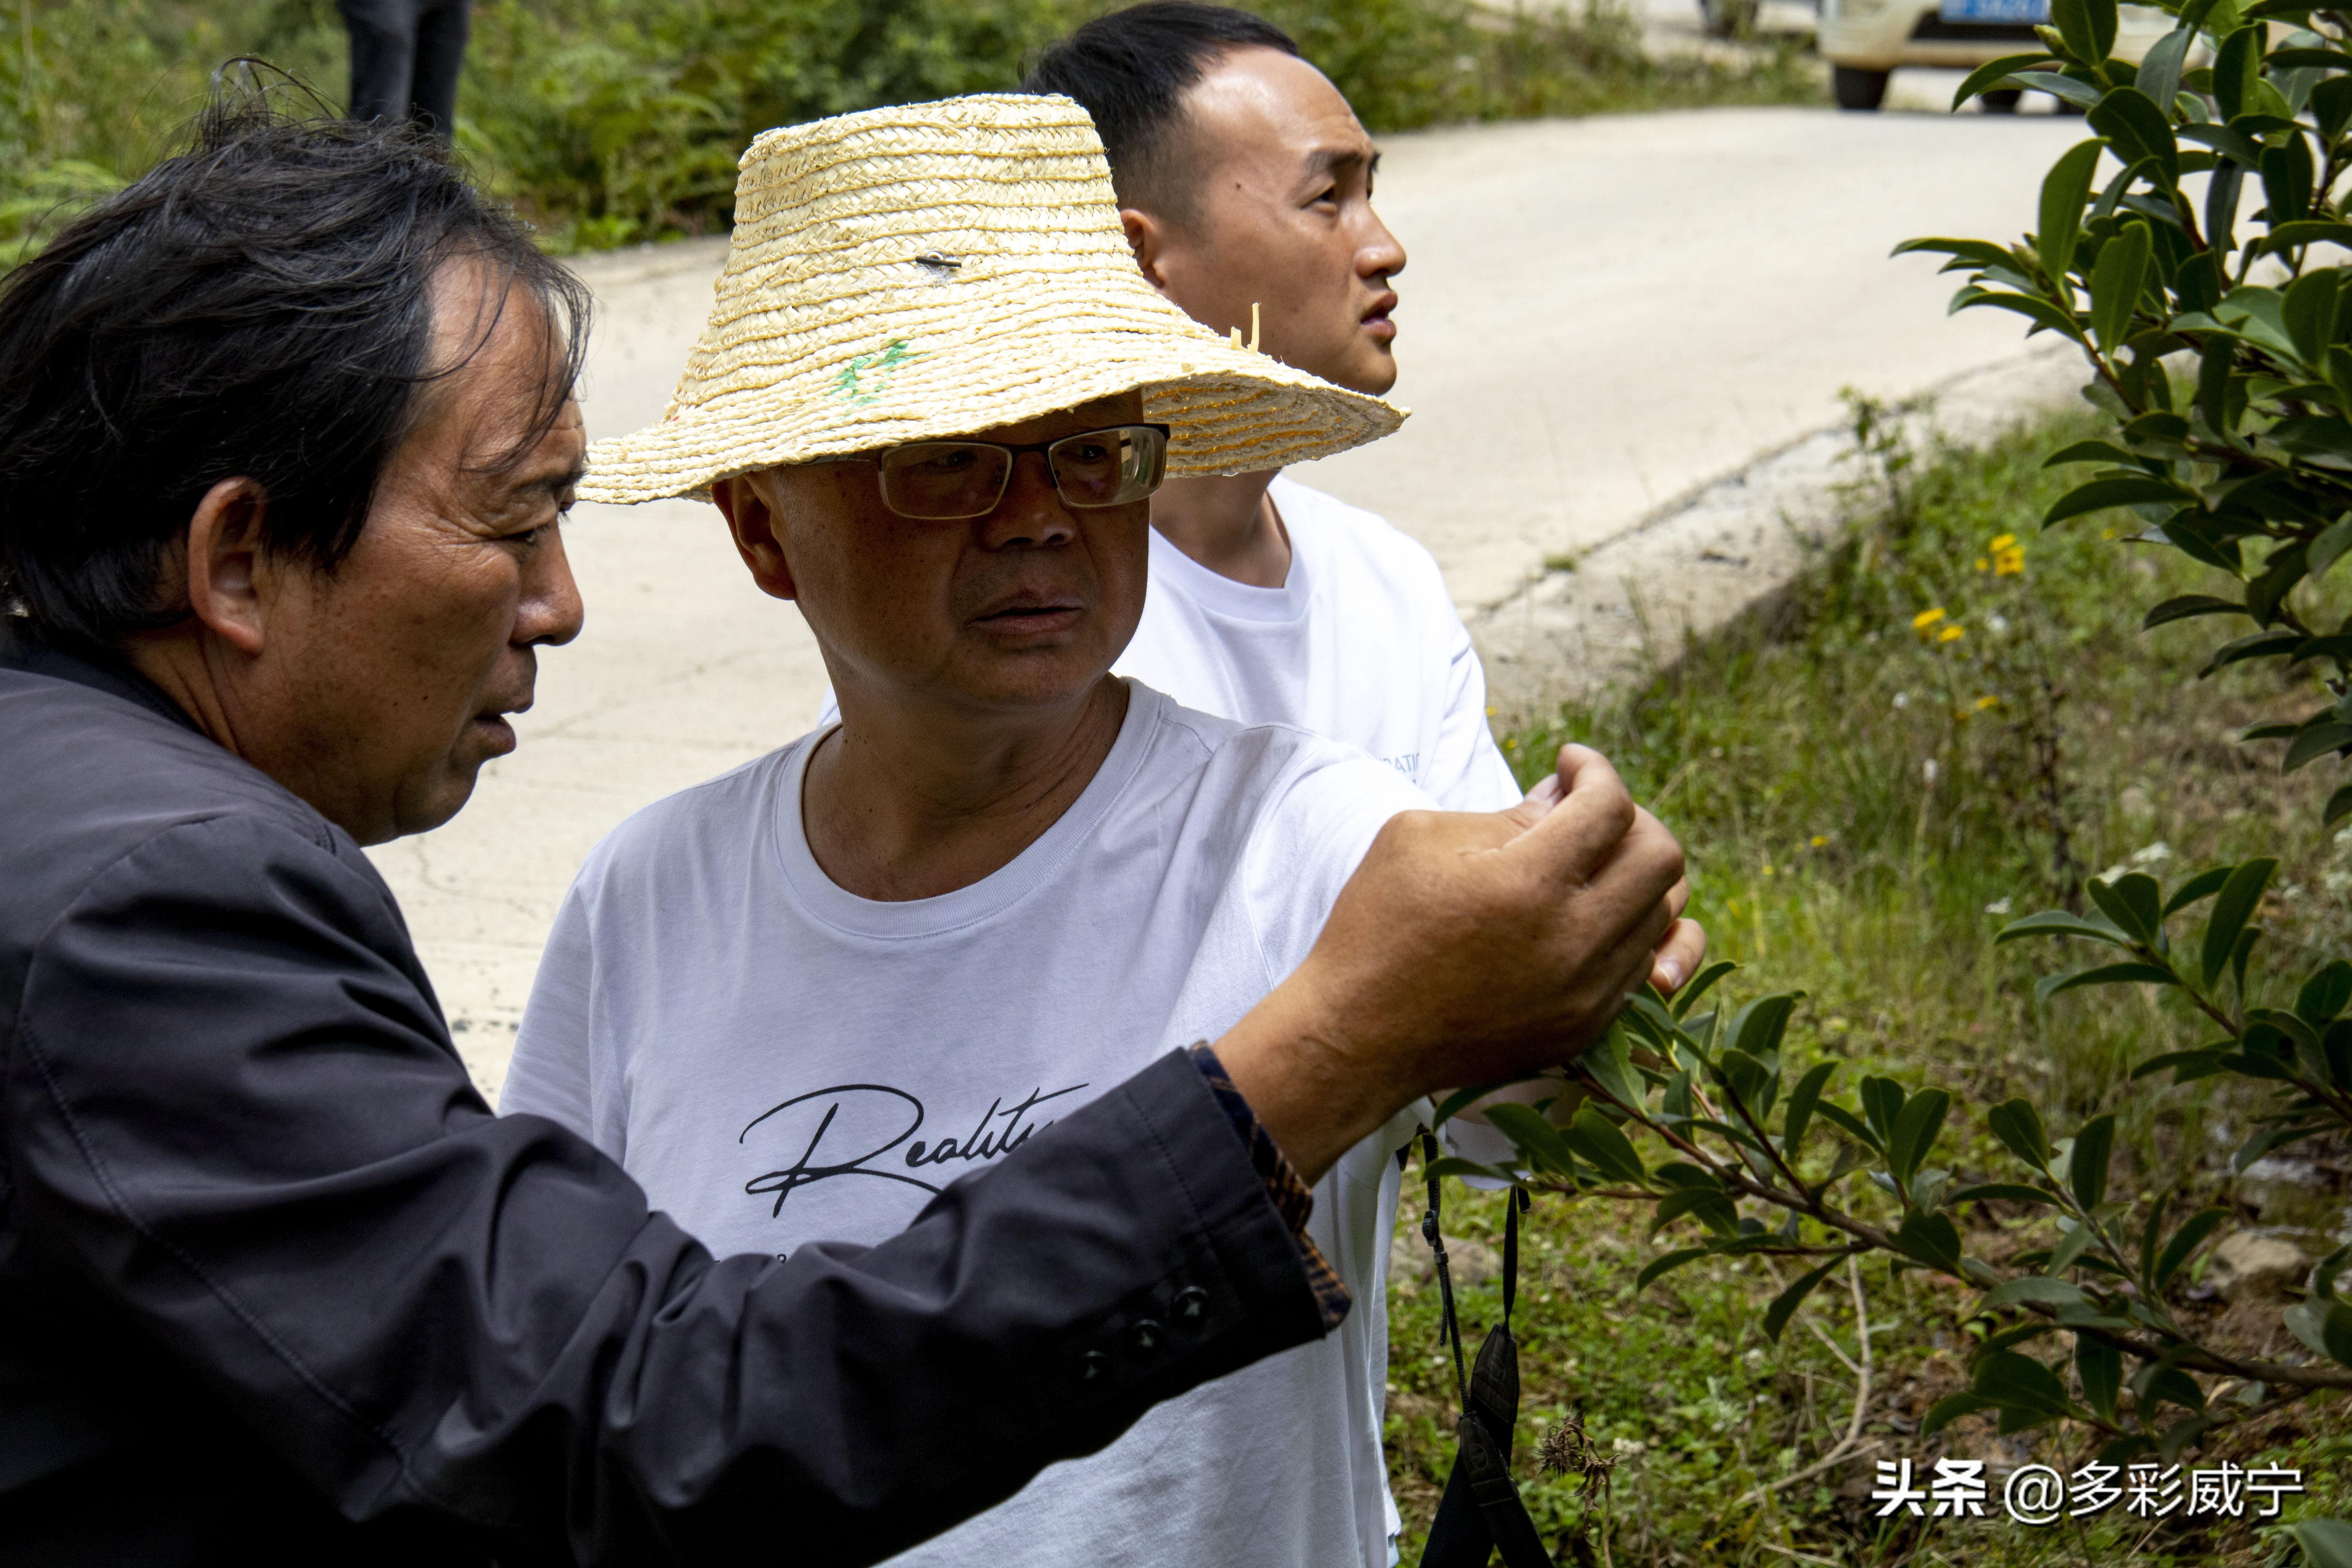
[1021,0,1298,223]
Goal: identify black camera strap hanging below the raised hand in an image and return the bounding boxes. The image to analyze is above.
[1421,1133,1552,1568]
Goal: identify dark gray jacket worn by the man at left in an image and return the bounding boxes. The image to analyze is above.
[0,644,1324,1568]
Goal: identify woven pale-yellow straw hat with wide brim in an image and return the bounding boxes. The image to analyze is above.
[579,94,1404,503]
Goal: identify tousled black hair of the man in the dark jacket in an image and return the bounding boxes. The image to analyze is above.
[0,73,588,646]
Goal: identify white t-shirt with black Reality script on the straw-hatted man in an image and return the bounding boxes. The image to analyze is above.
[503,682,1428,1568]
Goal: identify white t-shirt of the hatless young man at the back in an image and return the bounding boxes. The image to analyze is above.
[1115,475,1522,811]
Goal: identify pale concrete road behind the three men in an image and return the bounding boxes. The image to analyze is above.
[376,111,2084,1091]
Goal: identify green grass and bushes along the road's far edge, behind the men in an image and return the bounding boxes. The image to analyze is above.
[0,0,1823,263]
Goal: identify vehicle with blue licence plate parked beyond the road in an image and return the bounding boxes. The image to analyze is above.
[1820,0,2173,113]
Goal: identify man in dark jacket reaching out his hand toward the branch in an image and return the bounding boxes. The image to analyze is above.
[0,111,1698,1568]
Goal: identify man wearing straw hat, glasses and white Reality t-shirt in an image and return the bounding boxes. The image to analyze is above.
[506,96,1698,1568]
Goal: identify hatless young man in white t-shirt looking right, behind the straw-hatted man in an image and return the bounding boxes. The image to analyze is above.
[1023,0,1519,811]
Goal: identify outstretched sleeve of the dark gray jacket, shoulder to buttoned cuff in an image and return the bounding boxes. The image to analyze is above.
[5,818,1322,1563]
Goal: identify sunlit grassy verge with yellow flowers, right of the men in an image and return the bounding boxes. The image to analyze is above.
[1388,414,2352,1566]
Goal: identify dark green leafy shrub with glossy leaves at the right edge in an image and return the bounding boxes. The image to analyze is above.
[1444,0,2352,1563]
